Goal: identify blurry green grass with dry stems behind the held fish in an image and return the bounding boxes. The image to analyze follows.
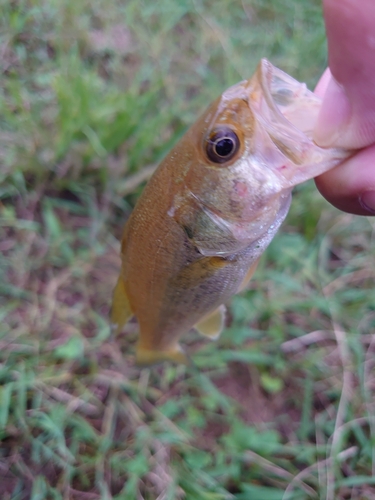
[0,0,375,500]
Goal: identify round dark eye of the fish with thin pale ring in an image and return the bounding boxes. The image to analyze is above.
[206,127,240,163]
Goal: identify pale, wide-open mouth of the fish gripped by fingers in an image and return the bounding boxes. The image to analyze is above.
[247,59,351,187]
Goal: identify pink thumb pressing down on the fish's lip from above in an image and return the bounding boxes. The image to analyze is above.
[314,0,375,148]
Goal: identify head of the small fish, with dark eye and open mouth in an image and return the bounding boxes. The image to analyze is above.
[184,60,347,230]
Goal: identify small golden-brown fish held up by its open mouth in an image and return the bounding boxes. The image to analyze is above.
[111,59,351,366]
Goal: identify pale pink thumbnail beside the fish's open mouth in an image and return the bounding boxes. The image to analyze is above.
[314,77,351,147]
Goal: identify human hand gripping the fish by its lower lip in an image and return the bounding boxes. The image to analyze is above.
[314,0,375,215]
